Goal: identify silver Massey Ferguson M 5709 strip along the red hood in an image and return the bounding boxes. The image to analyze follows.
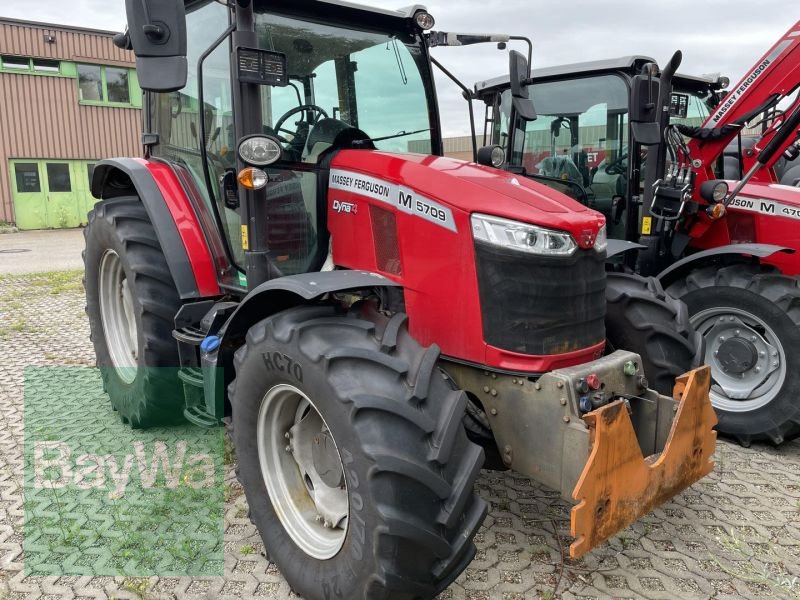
[330,169,457,232]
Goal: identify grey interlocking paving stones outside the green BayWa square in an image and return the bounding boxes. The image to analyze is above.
[0,274,800,600]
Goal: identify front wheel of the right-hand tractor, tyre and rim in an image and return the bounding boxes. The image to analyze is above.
[669,264,800,446]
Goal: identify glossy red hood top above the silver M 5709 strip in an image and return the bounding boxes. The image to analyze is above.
[331,150,605,239]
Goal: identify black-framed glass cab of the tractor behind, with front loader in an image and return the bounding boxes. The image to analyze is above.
[475,56,720,239]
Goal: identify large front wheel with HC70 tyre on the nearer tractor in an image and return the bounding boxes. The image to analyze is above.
[230,306,487,599]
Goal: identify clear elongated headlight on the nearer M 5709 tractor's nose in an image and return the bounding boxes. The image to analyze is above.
[472,213,578,256]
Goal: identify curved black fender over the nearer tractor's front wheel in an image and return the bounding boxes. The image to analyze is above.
[208,270,400,419]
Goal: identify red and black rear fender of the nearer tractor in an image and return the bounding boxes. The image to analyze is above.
[91,158,220,300]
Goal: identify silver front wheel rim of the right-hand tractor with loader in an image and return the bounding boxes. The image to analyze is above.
[690,307,786,412]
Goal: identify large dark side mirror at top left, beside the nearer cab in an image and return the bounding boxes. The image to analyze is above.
[123,0,188,92]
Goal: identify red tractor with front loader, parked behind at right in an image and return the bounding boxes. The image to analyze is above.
[475,22,800,445]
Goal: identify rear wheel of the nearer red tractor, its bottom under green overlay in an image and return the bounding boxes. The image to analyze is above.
[83,196,184,428]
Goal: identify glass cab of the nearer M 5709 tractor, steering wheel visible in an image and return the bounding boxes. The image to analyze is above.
[137,1,441,287]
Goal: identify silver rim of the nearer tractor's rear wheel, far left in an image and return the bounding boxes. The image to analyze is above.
[99,250,139,383]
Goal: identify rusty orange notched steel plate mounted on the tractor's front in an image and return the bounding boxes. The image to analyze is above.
[570,366,717,558]
